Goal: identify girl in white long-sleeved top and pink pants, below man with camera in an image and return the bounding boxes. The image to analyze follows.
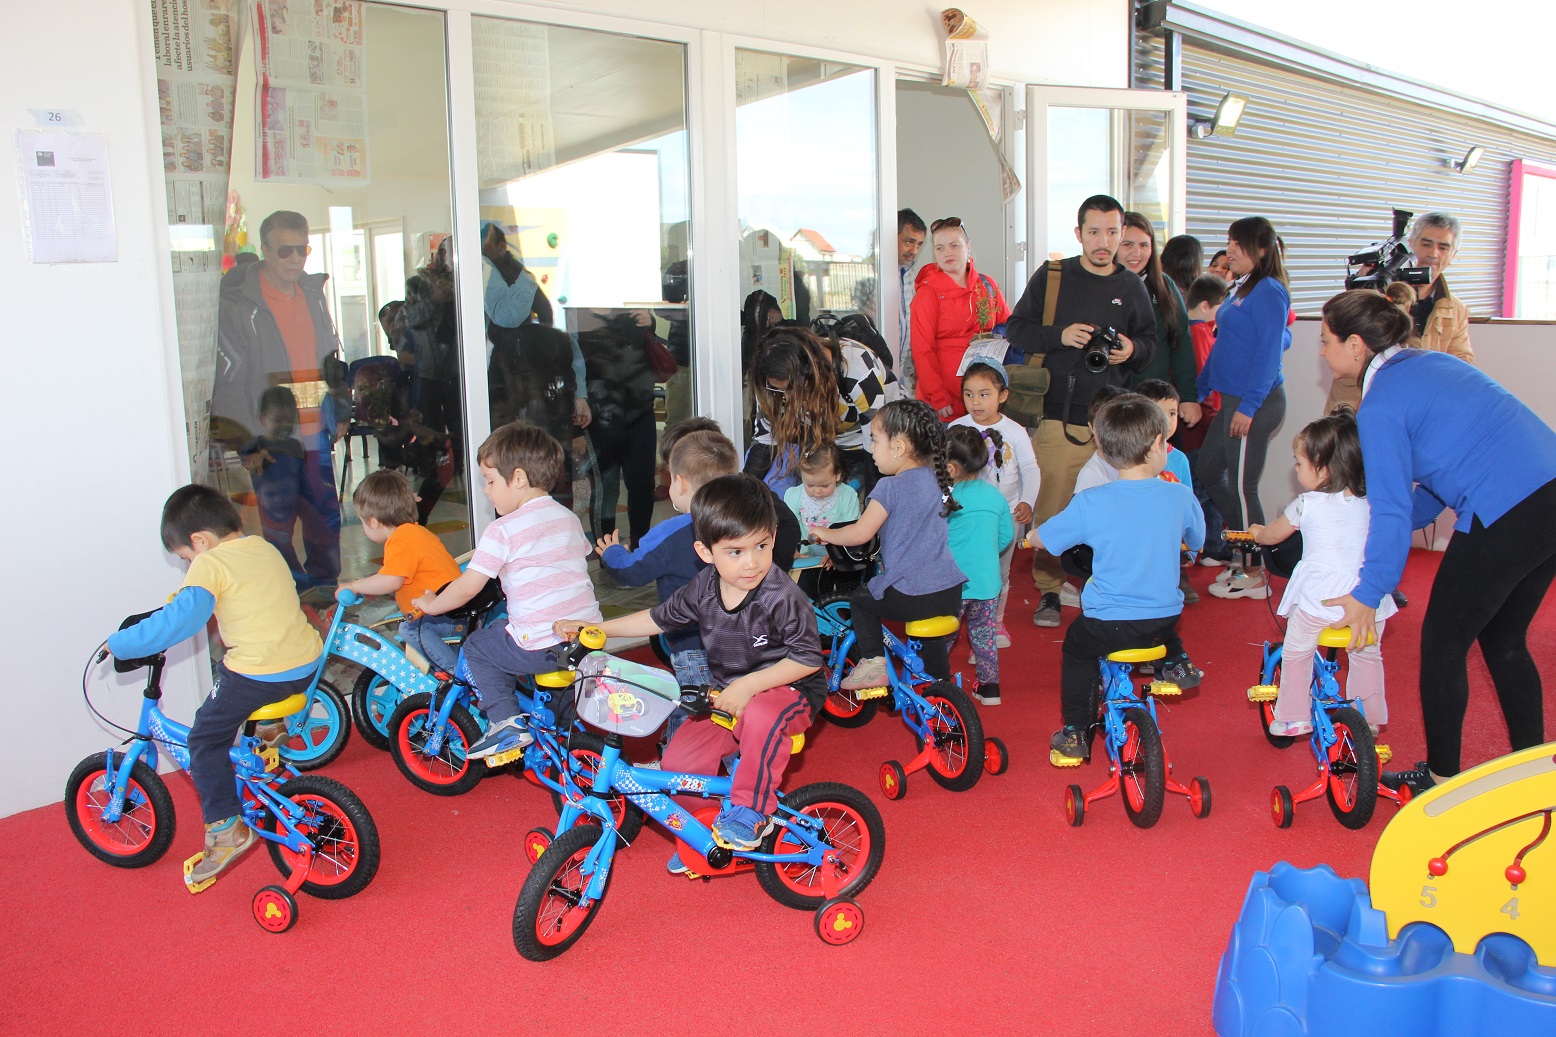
[951,357,1043,648]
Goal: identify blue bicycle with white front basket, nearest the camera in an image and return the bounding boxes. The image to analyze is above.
[513,627,885,961]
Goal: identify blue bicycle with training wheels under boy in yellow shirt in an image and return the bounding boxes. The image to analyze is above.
[65,629,378,933]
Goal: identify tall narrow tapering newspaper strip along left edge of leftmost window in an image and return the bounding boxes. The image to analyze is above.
[149,0,243,472]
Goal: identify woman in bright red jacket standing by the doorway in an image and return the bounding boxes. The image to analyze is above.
[912,216,1010,422]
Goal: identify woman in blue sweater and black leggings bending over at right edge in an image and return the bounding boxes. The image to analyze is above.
[1321,291,1556,791]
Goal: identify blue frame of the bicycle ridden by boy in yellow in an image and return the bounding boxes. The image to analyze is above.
[103,656,331,853]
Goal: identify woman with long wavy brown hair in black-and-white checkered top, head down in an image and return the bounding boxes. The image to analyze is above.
[745,324,898,495]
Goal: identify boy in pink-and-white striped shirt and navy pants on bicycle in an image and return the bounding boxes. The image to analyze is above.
[414,422,601,760]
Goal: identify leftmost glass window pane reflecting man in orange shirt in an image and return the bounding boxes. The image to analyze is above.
[157,0,471,606]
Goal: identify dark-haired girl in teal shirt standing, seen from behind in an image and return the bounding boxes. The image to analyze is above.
[946,425,1016,705]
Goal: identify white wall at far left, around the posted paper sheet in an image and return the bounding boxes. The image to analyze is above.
[0,0,208,814]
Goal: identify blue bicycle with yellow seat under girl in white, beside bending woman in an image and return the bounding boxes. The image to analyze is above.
[1248,616,1410,828]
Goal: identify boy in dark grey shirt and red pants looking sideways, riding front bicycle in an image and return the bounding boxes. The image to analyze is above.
[555,475,826,853]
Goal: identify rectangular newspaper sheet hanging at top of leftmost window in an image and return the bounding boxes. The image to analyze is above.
[251,0,370,184]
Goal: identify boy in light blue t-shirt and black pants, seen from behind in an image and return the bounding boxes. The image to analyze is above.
[1032,394,1204,766]
